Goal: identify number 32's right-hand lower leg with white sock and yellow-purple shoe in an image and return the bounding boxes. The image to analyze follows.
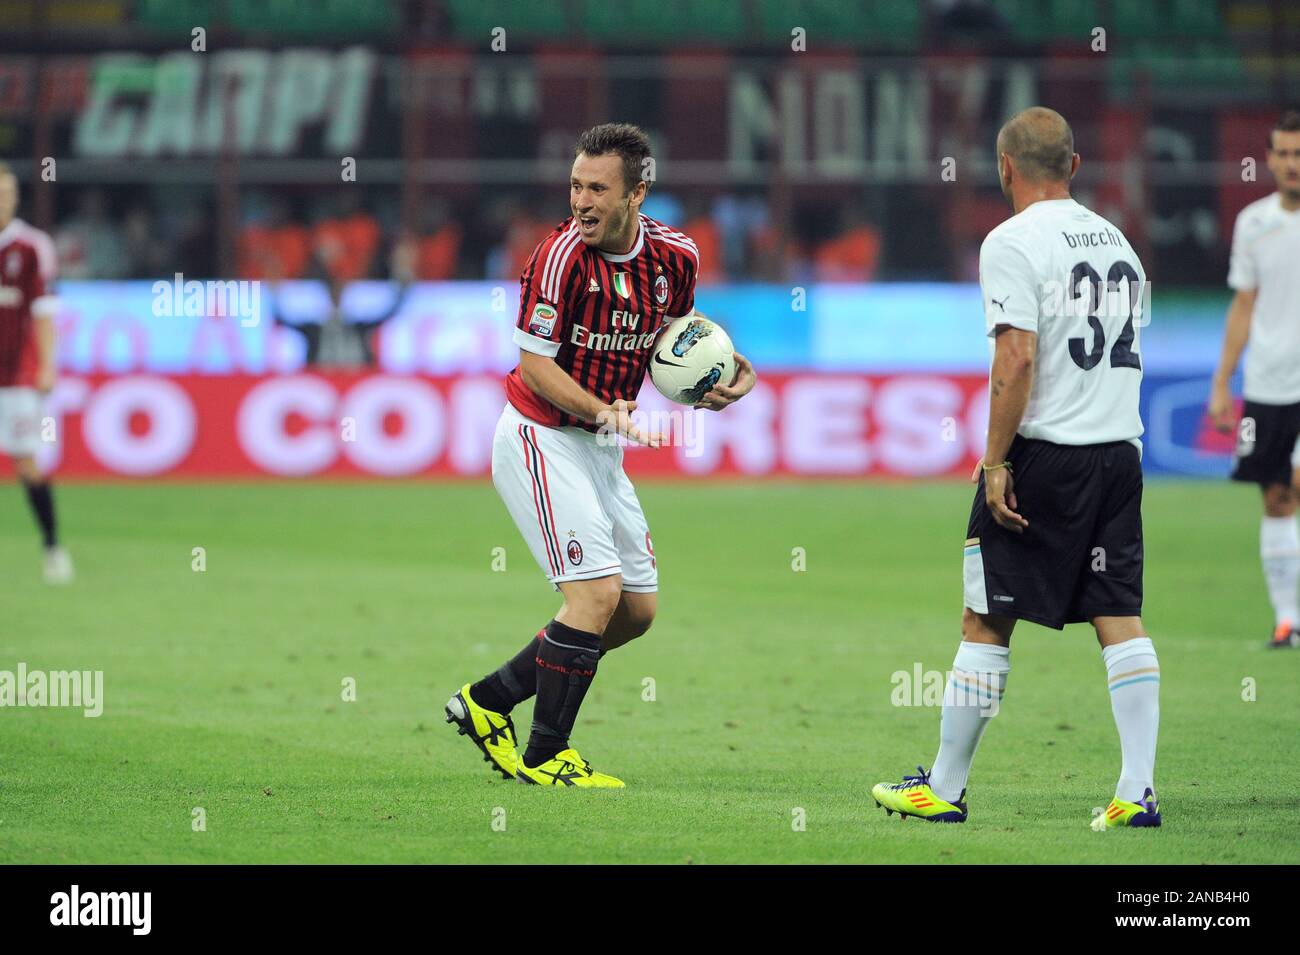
[1092,617,1160,828]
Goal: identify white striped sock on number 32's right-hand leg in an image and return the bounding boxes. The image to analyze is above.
[1101,637,1160,803]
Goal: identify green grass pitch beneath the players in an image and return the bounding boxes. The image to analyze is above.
[0,481,1300,863]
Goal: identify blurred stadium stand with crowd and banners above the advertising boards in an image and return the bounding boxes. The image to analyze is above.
[0,0,1300,286]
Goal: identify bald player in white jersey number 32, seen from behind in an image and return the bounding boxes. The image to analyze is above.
[871,107,1160,828]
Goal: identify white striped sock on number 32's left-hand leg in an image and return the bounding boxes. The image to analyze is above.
[930,641,1011,803]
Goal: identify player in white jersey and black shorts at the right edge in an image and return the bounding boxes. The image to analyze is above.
[1209,110,1300,647]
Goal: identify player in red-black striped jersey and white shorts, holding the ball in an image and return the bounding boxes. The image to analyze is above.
[446,123,755,787]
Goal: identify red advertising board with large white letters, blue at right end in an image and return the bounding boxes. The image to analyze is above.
[15,373,1231,478]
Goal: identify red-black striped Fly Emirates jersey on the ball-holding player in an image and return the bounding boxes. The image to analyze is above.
[506,216,699,431]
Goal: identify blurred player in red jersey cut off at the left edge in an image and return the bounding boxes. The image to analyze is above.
[0,164,73,583]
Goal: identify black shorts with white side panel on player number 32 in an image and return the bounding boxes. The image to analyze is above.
[963,435,1143,630]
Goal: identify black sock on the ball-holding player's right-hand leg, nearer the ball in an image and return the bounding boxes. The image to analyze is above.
[524,620,601,767]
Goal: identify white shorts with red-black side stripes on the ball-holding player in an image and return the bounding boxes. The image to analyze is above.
[491,404,659,594]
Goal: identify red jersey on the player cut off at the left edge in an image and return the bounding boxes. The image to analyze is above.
[0,218,55,388]
